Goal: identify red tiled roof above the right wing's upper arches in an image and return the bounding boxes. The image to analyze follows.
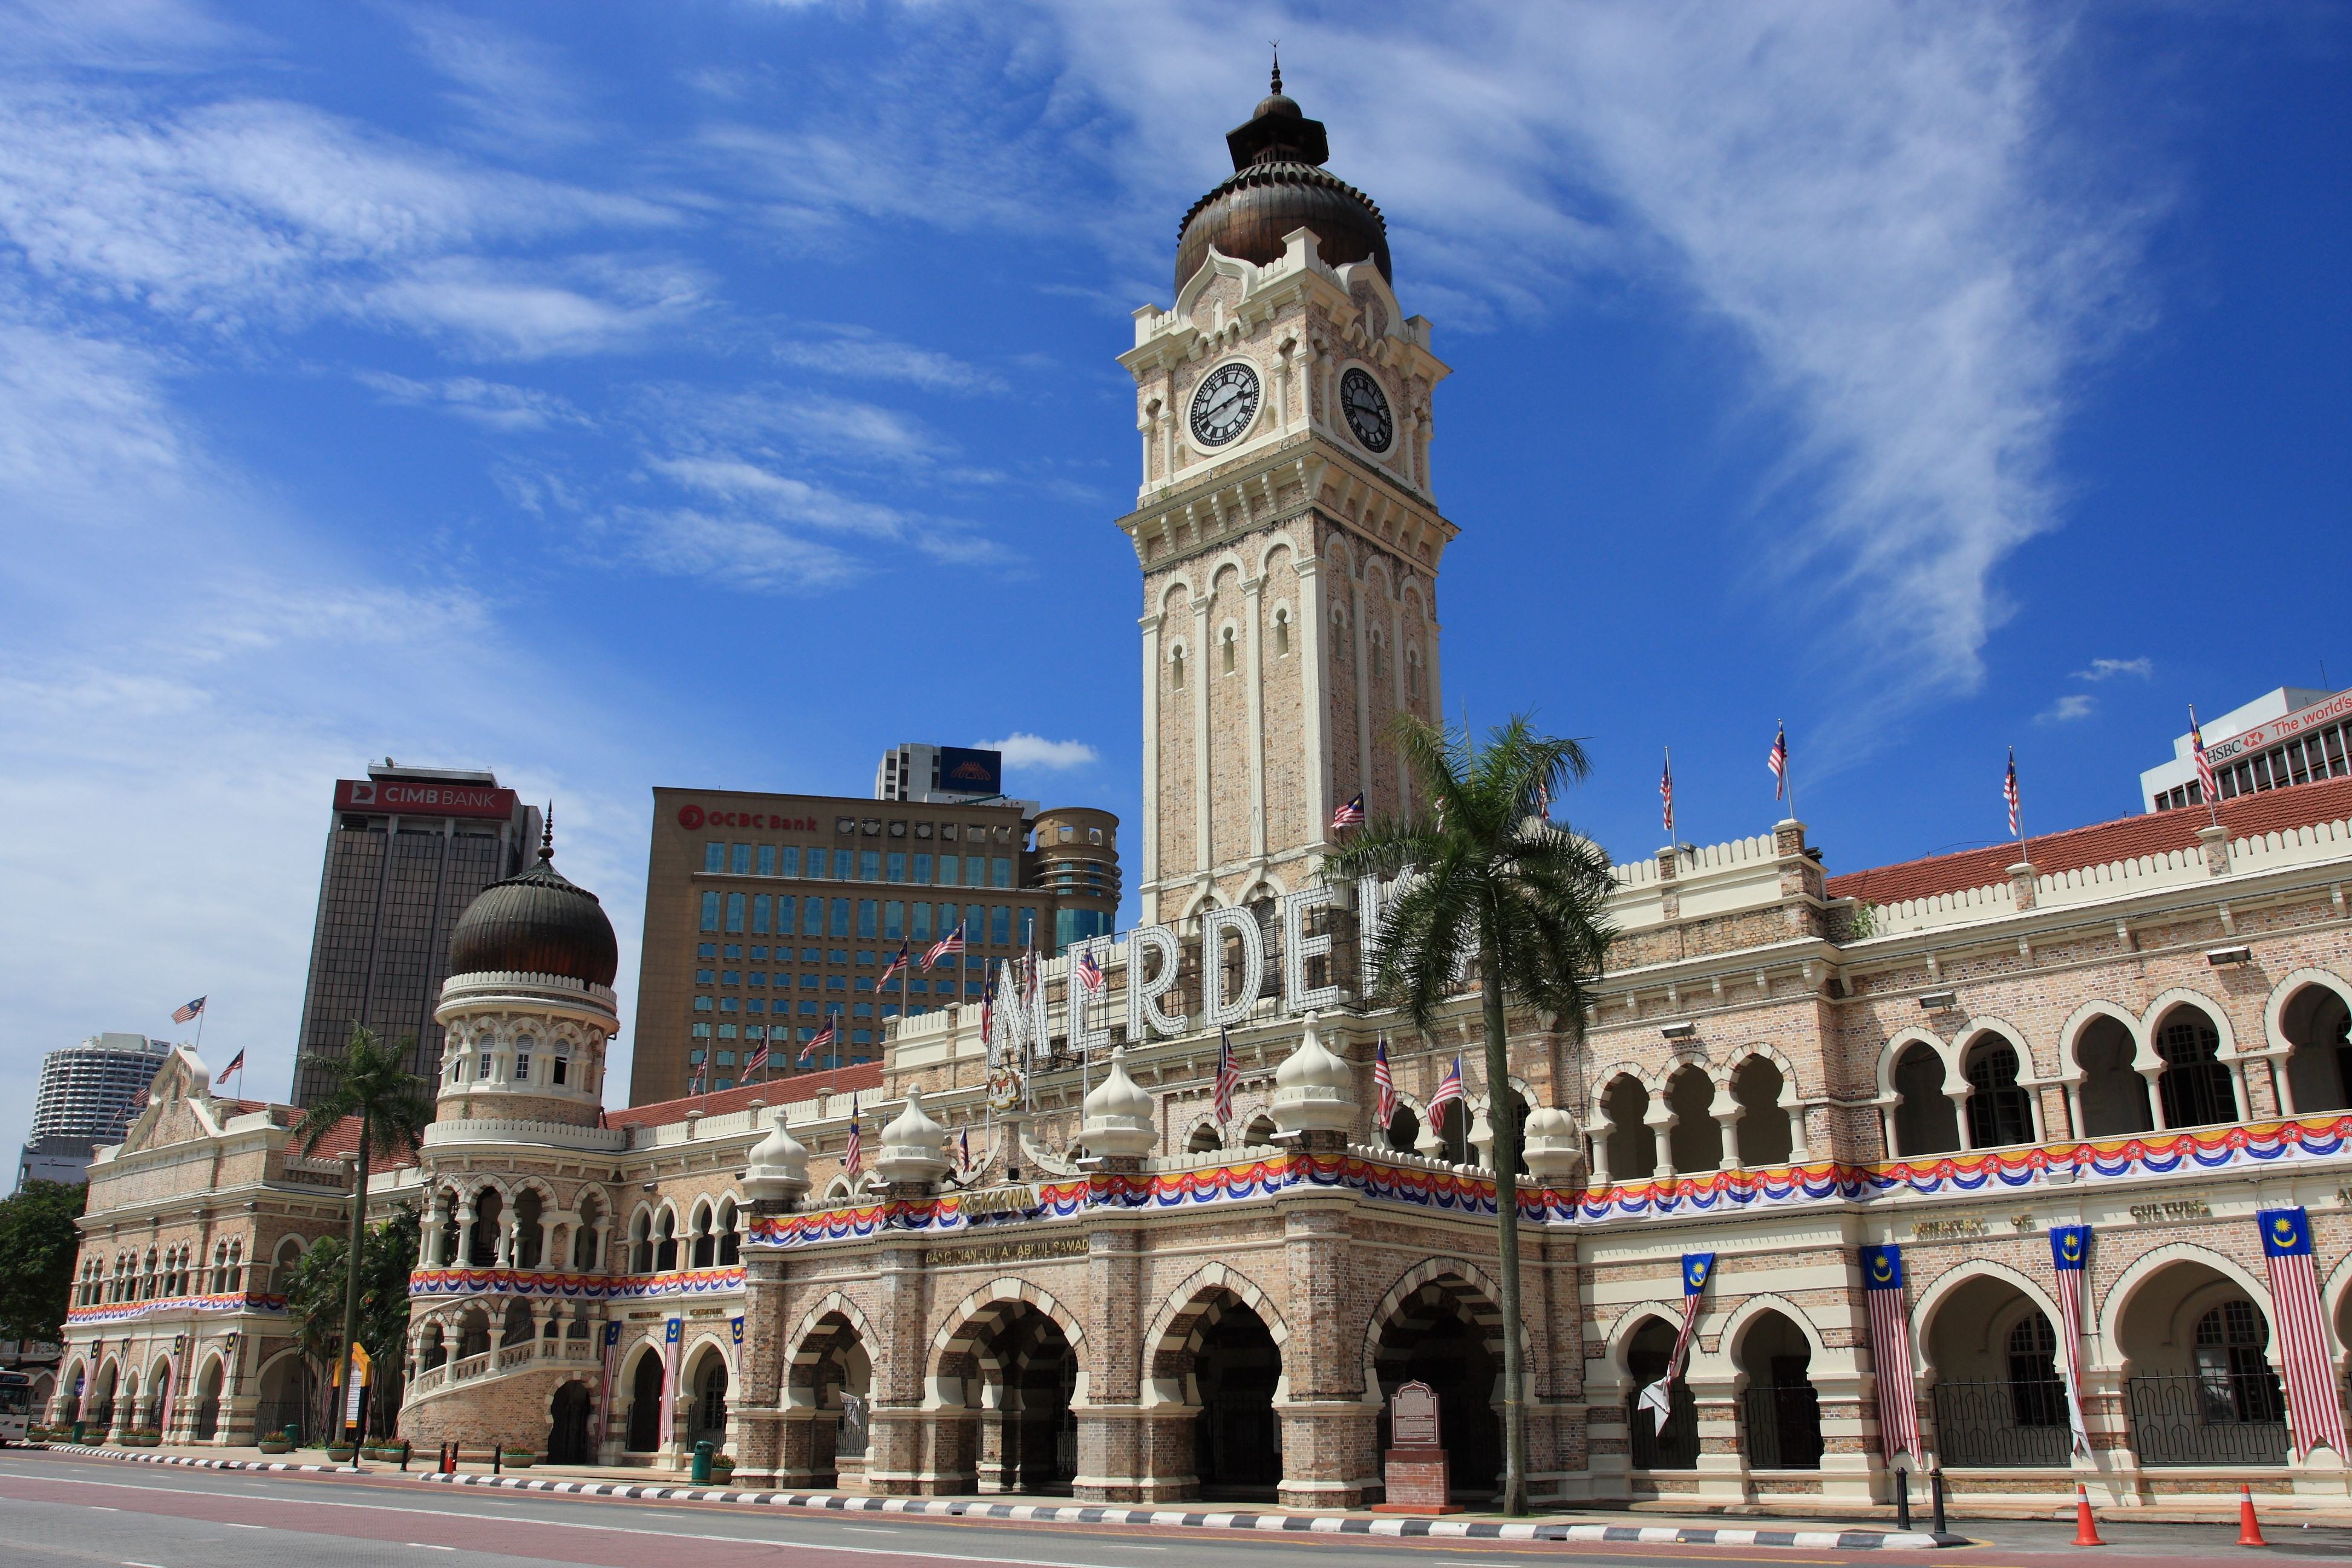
[1830,778,2352,905]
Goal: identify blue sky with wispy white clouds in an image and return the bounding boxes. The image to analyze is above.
[0,0,2352,1145]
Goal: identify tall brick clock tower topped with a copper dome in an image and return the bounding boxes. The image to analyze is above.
[1120,66,1454,921]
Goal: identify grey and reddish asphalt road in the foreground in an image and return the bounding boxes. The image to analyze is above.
[0,1453,2352,1568]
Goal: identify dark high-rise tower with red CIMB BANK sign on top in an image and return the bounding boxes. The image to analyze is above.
[292,759,541,1105]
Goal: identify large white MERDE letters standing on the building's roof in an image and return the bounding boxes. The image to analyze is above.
[988,877,1399,1060]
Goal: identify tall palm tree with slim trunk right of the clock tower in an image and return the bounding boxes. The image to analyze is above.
[1324,714,1616,1514]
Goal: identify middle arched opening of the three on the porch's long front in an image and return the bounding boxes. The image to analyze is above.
[938,1300,1077,1495]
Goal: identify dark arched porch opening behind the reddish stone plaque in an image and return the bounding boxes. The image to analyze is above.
[1374,1274,1503,1500]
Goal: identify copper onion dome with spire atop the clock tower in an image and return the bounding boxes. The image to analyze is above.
[1176,61,1395,292]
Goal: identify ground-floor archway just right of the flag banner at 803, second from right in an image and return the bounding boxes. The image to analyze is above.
[1921,1274,2074,1469]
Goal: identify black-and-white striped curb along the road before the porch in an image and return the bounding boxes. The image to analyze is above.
[416,1472,1973,1552]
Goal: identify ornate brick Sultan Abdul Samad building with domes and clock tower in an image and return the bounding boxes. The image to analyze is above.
[54,76,2352,1507]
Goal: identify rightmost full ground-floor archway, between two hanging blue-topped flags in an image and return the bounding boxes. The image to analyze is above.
[2117,1258,2286,1465]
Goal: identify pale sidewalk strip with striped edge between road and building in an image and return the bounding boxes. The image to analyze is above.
[36,1443,1973,1552]
